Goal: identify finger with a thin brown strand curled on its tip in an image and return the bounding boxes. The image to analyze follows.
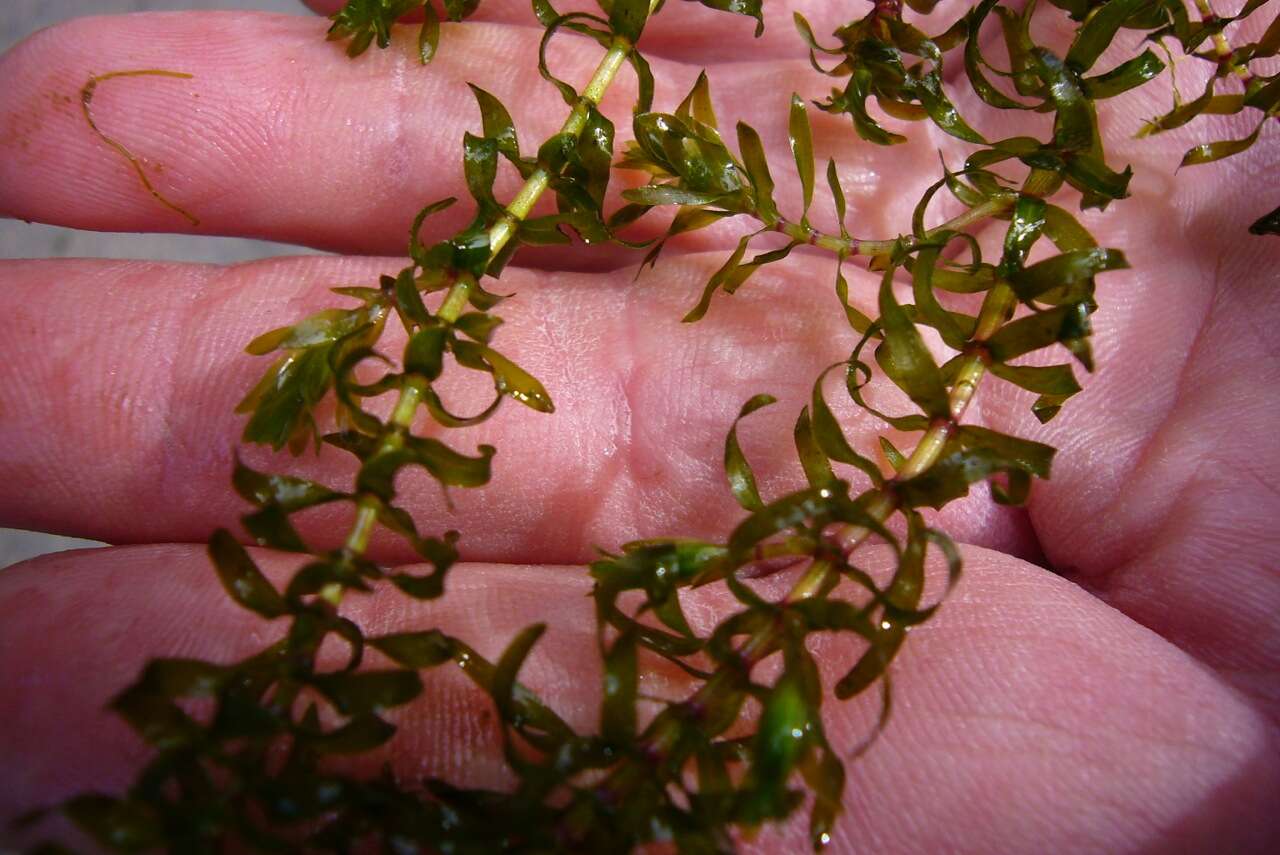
[0,13,957,266]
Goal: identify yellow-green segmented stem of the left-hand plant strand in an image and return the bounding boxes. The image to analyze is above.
[335,0,662,573]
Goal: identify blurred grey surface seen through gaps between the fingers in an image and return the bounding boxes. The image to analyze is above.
[0,0,310,567]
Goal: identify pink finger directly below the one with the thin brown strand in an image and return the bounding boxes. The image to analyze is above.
[0,255,1034,562]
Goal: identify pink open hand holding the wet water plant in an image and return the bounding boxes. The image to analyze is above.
[0,3,1280,852]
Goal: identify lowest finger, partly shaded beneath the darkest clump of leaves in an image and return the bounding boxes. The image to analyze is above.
[0,547,1280,852]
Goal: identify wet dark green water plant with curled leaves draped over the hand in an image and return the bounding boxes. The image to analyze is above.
[27,0,1280,852]
